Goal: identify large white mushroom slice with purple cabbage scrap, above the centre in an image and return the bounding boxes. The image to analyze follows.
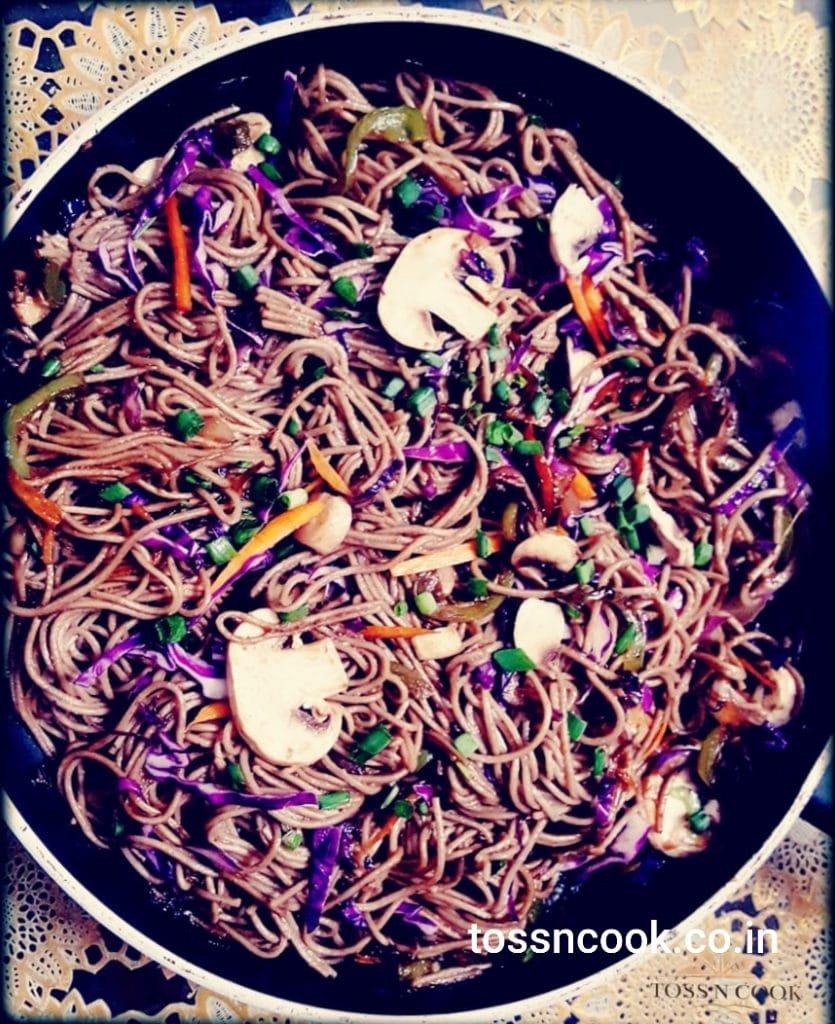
[377,227,504,352]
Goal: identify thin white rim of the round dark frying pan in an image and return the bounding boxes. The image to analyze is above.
[2,5,832,1024]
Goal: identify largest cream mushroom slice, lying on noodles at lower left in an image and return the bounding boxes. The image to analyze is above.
[226,609,348,765]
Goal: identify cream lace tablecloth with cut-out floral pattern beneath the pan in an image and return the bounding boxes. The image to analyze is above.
[4,0,831,1024]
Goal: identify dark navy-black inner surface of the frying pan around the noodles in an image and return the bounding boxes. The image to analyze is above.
[4,15,833,1020]
